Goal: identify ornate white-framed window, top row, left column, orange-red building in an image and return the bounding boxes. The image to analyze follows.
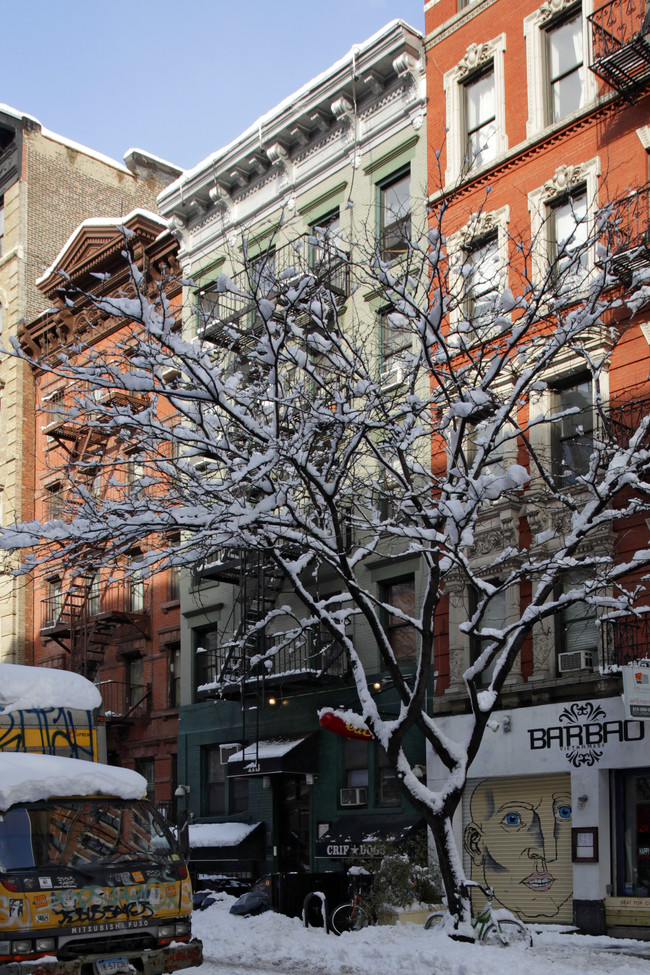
[443,34,508,186]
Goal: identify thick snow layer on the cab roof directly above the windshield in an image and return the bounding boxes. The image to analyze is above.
[0,752,147,810]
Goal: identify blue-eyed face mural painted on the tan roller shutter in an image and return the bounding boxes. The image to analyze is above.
[464,776,572,920]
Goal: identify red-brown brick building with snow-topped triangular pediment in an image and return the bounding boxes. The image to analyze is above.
[20,210,181,816]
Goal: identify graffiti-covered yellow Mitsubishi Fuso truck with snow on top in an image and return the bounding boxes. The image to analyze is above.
[0,664,202,975]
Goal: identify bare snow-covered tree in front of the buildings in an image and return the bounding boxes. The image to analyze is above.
[2,200,650,929]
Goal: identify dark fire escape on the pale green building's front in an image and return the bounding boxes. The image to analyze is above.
[198,226,350,703]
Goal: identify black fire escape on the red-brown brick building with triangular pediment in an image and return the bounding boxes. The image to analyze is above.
[40,391,151,680]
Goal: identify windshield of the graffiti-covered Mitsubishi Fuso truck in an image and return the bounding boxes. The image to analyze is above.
[0,799,177,871]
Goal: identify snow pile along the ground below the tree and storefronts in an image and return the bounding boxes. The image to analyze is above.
[187,894,650,975]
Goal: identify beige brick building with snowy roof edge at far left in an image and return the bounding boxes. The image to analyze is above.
[0,105,180,663]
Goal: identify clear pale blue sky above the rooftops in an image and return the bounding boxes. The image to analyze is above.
[6,0,424,168]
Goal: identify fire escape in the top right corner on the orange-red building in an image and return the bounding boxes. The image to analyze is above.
[588,0,650,103]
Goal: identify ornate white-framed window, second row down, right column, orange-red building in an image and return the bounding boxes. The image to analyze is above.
[528,157,600,289]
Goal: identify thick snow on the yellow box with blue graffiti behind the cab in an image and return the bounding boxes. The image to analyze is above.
[0,664,102,714]
